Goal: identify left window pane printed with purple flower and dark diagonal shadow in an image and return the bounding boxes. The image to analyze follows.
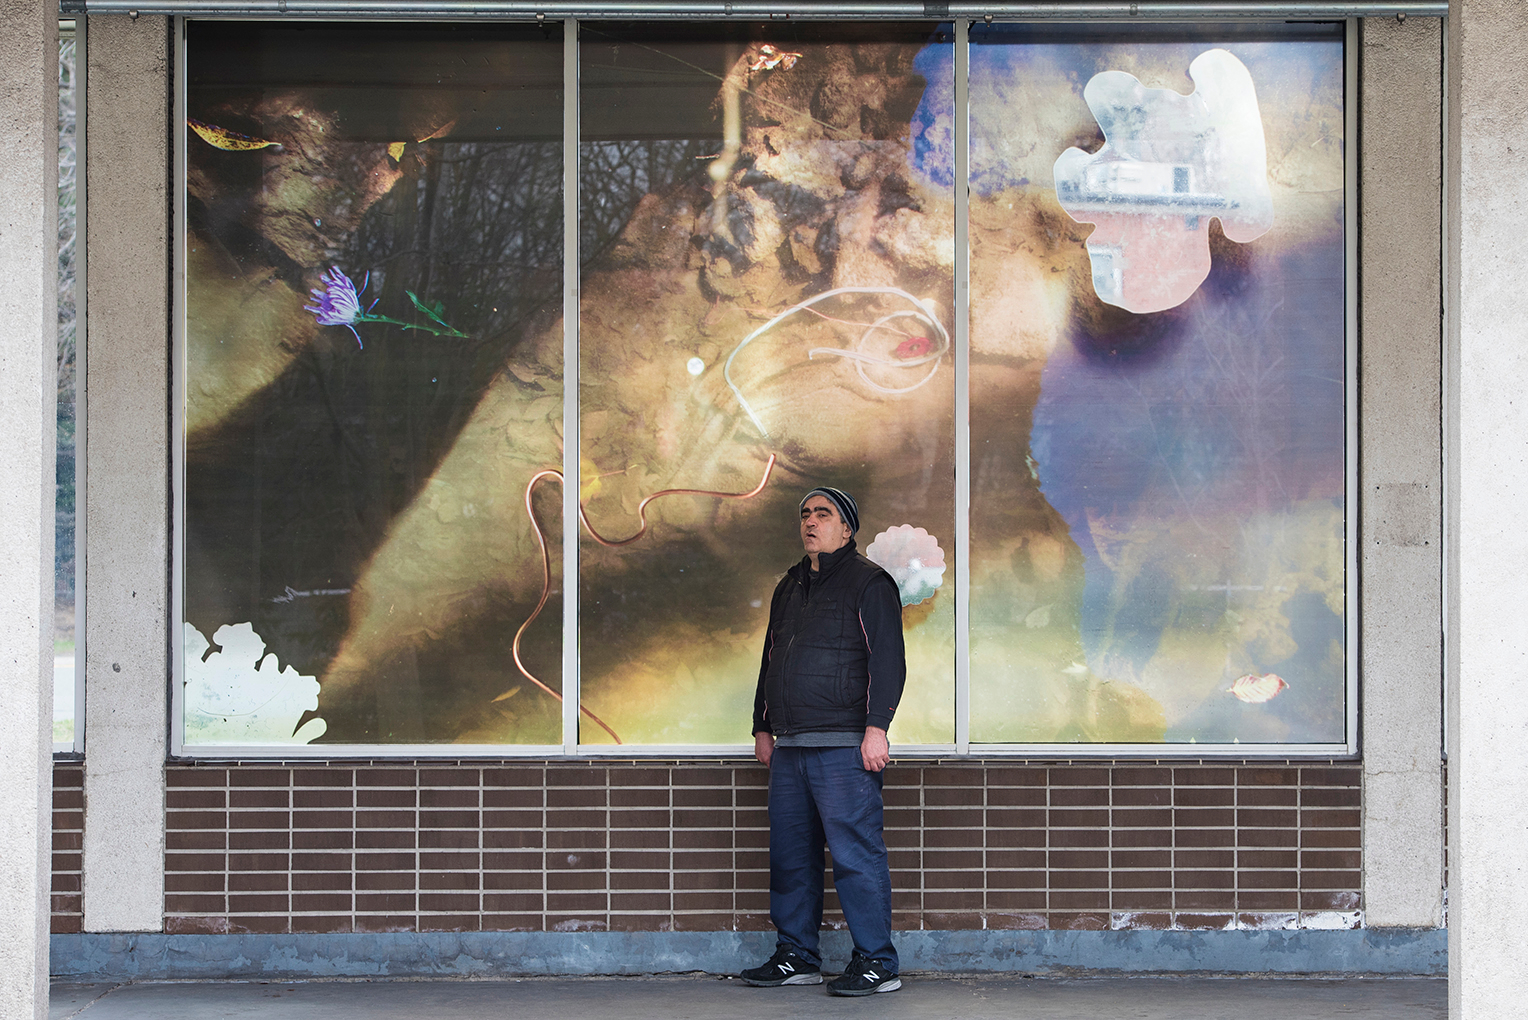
[180,21,562,747]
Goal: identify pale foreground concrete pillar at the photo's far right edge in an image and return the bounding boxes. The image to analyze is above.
[1447,0,1528,1020]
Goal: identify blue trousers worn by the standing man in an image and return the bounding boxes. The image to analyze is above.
[769,747,897,974]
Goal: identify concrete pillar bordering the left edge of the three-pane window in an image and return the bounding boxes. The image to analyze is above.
[81,15,173,931]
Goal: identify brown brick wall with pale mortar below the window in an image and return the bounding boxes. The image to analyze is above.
[98,760,1361,931]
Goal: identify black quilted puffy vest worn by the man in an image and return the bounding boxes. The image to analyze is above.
[764,547,885,736]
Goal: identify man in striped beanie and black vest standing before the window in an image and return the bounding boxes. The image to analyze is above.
[741,487,908,996]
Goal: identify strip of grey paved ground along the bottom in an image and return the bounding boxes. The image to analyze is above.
[50,976,1449,1020]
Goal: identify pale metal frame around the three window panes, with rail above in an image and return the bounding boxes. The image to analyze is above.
[175,9,1362,760]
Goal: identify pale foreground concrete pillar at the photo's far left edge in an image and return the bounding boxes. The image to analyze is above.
[0,0,58,1020]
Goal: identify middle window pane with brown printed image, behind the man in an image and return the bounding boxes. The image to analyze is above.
[579,23,960,745]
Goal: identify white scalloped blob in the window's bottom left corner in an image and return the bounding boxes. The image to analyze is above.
[183,623,329,745]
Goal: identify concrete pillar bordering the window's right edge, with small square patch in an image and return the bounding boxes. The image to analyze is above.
[1349,18,1442,928]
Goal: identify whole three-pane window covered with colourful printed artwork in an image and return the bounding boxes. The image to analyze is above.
[176,18,1354,754]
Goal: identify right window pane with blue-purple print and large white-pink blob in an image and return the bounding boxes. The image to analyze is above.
[970,26,1346,744]
